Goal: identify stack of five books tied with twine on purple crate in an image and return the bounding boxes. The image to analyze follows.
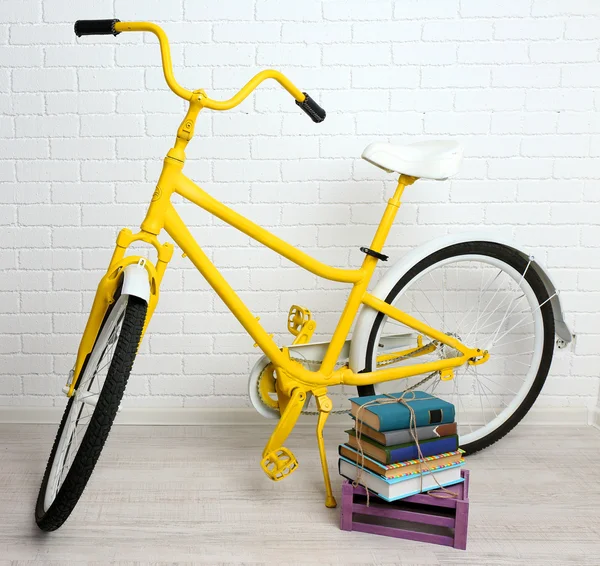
[339,391,464,501]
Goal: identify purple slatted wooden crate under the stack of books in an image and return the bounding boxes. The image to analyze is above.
[340,470,469,550]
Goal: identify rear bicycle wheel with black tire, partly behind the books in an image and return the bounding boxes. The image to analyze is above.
[359,242,554,453]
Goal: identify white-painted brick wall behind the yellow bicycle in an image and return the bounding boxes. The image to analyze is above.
[0,0,600,412]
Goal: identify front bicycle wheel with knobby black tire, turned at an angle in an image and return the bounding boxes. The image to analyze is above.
[35,295,147,531]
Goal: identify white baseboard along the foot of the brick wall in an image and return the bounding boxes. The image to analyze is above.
[0,407,600,428]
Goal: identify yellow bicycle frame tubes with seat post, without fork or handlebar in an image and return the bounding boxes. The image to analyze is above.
[168,172,474,380]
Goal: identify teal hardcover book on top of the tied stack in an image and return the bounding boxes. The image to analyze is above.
[350,391,454,432]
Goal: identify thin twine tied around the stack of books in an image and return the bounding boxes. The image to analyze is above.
[352,390,458,507]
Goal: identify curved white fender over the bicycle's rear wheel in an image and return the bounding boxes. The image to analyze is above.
[350,231,572,372]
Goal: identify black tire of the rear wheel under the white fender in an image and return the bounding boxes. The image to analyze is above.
[357,242,554,454]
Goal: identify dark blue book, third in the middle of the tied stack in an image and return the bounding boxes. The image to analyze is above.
[346,429,458,464]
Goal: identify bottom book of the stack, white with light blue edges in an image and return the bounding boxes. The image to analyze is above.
[338,458,464,501]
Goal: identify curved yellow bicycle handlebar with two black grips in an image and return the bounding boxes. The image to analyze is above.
[75,19,326,123]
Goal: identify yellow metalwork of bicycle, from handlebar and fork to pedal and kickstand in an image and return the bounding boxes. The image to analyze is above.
[68,22,484,507]
